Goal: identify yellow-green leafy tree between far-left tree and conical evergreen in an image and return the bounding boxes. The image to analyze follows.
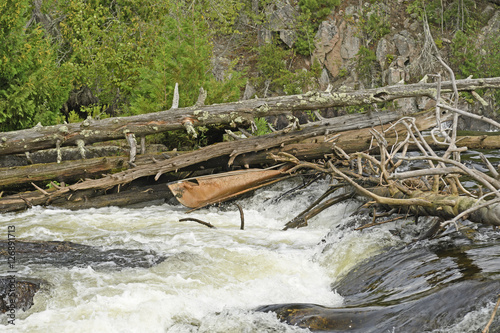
[56,0,156,115]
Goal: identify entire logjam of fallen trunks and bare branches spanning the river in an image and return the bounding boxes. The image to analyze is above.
[0,73,500,233]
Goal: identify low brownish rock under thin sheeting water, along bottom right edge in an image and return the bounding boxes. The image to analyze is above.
[257,281,500,333]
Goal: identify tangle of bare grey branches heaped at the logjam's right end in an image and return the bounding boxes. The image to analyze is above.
[274,105,500,228]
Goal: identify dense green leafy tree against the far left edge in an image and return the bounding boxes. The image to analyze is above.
[0,0,69,131]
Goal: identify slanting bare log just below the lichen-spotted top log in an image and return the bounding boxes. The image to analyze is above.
[0,107,452,212]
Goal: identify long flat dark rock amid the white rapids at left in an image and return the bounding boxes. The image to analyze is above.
[0,241,166,268]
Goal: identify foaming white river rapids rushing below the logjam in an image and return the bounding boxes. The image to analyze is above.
[0,180,498,333]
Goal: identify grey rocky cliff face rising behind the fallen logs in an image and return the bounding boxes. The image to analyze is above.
[228,0,500,130]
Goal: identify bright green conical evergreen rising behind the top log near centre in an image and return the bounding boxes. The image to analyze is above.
[130,5,244,114]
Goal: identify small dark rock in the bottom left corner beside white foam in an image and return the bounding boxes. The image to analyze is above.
[0,275,44,312]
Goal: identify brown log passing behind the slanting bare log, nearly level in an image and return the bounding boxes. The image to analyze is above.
[5,126,500,192]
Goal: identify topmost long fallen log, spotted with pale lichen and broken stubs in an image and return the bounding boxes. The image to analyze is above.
[0,78,500,155]
